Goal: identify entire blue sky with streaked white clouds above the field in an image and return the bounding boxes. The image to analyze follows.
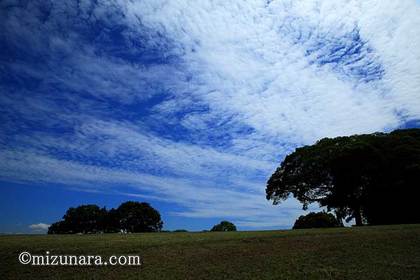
[0,0,420,232]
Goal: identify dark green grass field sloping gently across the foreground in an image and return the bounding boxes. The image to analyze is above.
[0,225,420,280]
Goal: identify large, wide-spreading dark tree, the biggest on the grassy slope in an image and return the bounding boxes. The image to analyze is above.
[266,129,420,225]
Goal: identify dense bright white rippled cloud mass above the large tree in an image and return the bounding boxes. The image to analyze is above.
[121,1,420,143]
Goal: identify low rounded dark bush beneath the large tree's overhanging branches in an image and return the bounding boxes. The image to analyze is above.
[293,212,343,229]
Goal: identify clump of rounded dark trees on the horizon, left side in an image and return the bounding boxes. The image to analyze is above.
[48,201,163,234]
